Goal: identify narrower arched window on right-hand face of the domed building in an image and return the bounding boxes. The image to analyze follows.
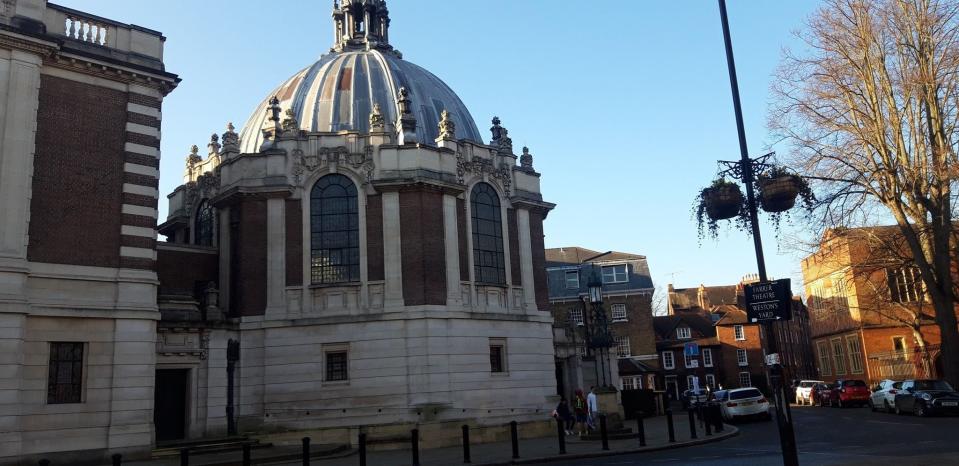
[470,183,506,285]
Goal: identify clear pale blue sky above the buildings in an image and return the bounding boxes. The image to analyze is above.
[57,0,818,292]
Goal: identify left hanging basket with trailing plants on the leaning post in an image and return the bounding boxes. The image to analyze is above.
[693,178,749,241]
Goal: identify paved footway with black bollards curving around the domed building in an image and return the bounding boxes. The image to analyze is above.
[114,412,738,466]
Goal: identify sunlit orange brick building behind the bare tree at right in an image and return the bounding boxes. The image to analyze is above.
[802,226,959,382]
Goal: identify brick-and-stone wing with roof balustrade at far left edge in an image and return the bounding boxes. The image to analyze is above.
[0,0,179,464]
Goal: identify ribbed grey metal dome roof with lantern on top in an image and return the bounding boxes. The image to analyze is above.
[240,0,483,153]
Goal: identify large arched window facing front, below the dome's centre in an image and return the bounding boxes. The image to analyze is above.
[310,174,360,283]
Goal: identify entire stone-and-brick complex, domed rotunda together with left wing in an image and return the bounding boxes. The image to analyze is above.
[0,0,555,464]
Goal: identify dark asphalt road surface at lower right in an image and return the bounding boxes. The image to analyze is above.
[552,405,959,466]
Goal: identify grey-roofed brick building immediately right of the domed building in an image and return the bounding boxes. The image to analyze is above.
[546,247,659,396]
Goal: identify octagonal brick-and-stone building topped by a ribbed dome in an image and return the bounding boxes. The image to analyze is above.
[154,0,556,441]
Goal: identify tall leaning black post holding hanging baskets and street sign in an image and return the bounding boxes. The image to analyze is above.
[719,0,799,466]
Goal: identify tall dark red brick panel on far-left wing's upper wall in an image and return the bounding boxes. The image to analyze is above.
[27,75,126,267]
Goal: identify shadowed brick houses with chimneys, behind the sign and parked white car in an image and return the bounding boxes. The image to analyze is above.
[656,276,814,397]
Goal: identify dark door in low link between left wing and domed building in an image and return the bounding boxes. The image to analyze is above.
[153,369,190,442]
